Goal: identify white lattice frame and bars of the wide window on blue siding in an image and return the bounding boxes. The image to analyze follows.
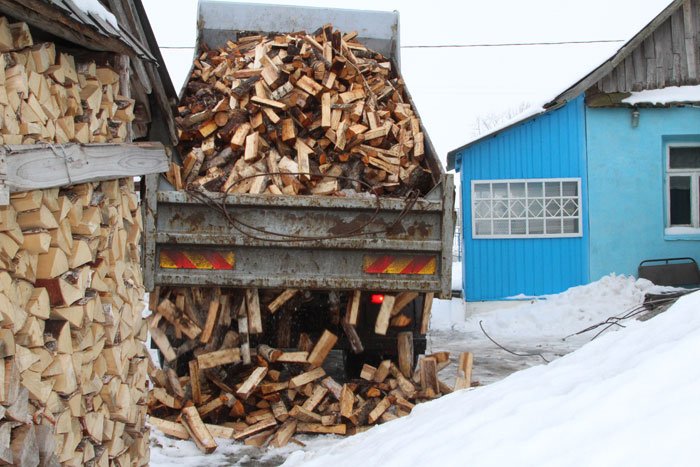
[470,178,583,239]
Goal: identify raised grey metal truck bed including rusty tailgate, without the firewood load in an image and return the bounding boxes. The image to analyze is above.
[144,1,454,298]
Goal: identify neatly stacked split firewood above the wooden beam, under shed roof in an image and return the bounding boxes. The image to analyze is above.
[0,17,134,145]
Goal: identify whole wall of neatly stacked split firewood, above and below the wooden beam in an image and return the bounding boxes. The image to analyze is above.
[0,18,150,467]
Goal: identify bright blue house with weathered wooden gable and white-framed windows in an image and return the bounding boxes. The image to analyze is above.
[448,0,700,301]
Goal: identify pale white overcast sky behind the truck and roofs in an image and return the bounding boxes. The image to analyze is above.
[143,0,670,168]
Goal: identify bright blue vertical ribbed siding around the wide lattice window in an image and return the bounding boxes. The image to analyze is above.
[458,97,588,301]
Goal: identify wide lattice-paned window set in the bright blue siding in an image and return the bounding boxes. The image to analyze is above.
[472,178,582,238]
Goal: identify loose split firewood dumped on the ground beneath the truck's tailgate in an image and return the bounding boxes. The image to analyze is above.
[147,288,473,453]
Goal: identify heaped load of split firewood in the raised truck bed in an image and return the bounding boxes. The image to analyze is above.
[168,25,431,195]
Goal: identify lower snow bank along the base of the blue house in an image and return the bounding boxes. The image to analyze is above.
[430,274,673,340]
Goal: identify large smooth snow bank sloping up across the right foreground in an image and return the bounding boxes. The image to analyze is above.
[284,290,700,467]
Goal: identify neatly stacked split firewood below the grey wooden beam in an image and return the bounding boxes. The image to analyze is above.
[0,179,150,466]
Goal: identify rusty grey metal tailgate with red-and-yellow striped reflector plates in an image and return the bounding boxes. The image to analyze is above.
[145,175,454,296]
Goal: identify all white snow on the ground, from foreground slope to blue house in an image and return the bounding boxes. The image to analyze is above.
[151,276,688,466]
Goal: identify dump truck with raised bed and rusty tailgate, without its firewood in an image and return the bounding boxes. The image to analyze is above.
[144,1,455,374]
